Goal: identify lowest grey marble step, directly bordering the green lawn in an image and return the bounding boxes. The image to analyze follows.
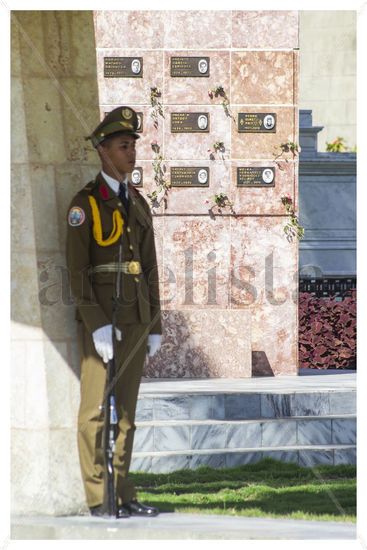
[130,445,356,473]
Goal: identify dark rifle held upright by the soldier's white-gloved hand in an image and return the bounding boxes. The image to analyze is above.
[102,241,122,517]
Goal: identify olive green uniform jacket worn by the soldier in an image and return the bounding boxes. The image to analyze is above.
[66,172,162,334]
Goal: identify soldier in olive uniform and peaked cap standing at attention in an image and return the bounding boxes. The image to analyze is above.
[66,106,162,518]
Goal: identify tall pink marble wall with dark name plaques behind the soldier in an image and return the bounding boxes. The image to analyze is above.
[94,10,299,378]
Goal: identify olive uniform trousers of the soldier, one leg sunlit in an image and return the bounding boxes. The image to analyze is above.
[77,321,149,507]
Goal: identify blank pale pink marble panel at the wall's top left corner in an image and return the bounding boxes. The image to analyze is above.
[94,10,165,49]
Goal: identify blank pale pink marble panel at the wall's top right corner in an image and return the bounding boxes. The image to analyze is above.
[232,10,298,48]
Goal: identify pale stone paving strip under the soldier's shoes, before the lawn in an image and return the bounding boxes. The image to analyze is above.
[11,512,356,540]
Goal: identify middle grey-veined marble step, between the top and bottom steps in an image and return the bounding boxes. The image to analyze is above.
[134,415,356,452]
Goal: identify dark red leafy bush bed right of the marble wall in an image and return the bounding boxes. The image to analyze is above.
[299,289,357,369]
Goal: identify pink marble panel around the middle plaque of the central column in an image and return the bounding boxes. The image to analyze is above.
[164,104,231,160]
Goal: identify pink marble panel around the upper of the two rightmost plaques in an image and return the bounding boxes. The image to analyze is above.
[231,105,298,160]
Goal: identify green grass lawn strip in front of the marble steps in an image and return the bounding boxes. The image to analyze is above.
[130,458,356,522]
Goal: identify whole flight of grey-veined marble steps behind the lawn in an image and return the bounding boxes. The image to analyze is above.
[130,381,356,473]
